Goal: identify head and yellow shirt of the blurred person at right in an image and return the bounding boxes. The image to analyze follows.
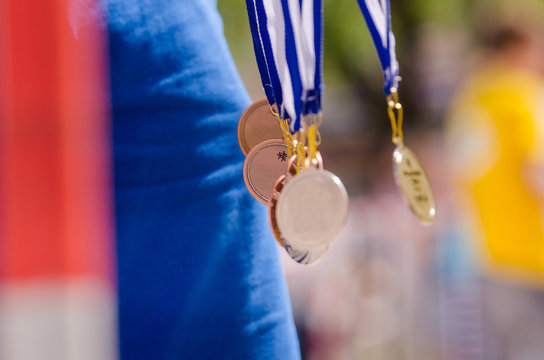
[446,24,544,285]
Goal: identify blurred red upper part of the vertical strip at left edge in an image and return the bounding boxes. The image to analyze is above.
[0,0,113,279]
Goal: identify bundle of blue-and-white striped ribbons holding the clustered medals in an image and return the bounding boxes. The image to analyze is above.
[246,0,323,133]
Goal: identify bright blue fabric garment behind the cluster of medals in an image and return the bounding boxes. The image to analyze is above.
[107,0,300,360]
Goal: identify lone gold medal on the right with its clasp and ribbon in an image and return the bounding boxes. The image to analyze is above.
[357,0,436,224]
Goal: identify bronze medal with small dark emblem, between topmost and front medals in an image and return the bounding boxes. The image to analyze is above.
[244,140,288,205]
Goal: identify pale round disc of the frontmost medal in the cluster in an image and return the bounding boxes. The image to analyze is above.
[276,169,348,252]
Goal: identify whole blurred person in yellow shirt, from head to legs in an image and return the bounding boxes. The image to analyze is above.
[445,25,544,359]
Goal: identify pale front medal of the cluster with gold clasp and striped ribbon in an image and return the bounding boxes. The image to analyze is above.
[275,0,348,264]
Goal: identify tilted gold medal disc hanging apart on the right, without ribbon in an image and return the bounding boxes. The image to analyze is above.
[393,145,436,223]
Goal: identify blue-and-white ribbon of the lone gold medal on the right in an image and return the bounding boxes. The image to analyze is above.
[357,0,400,96]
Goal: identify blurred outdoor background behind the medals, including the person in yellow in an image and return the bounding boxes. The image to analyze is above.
[218,0,544,360]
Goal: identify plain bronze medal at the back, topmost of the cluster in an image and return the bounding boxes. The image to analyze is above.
[238,99,283,155]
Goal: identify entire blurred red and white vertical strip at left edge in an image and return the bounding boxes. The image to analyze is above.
[0,0,117,360]
